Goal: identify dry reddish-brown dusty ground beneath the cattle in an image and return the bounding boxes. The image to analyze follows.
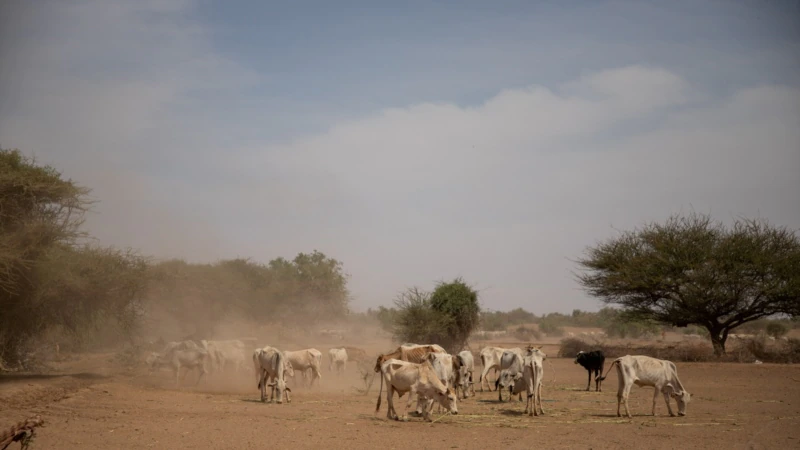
[0,345,800,449]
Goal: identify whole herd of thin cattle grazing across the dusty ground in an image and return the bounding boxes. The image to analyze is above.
[146,339,690,421]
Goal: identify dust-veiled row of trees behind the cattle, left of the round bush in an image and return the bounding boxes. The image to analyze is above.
[148,250,349,336]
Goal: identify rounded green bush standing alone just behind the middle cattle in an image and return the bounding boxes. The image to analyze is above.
[388,279,480,352]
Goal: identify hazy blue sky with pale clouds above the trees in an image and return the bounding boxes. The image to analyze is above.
[0,0,800,313]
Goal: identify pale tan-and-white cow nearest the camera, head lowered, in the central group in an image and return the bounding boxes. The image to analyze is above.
[375,359,458,421]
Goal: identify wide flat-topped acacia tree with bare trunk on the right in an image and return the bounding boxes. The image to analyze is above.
[576,214,800,355]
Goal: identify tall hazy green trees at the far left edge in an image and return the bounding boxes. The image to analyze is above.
[0,150,147,363]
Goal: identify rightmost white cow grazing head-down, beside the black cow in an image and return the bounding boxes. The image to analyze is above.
[600,355,691,418]
